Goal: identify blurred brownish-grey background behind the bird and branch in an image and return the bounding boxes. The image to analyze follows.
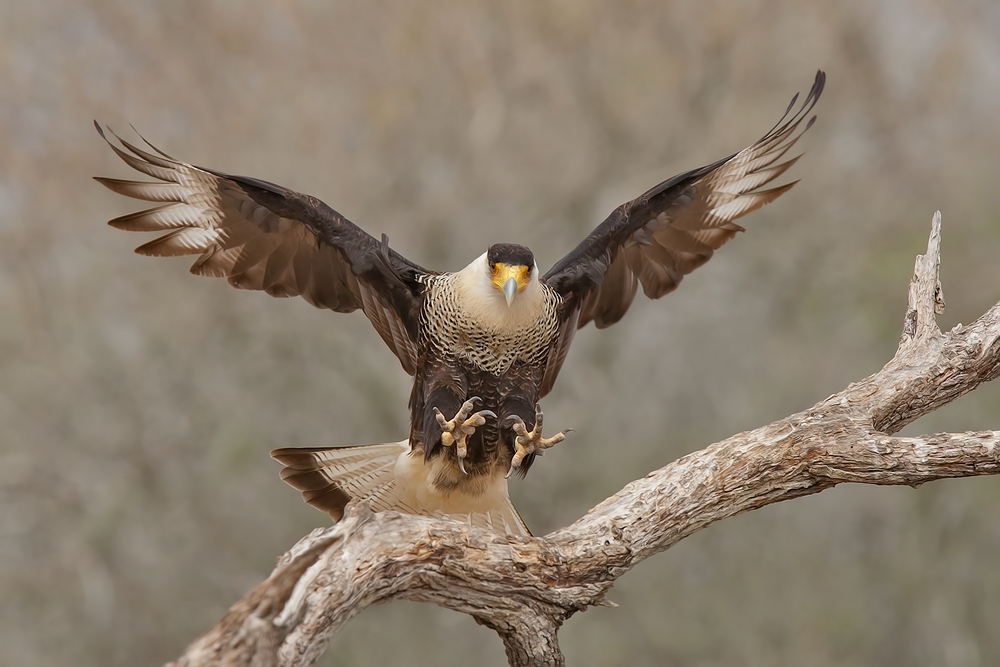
[0,0,1000,667]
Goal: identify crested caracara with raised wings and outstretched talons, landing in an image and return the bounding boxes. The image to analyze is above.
[94,70,826,536]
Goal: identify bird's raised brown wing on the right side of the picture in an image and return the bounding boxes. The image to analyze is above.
[542,71,826,394]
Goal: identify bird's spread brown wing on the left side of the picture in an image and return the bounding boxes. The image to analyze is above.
[94,122,429,375]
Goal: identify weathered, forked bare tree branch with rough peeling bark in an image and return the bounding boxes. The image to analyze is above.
[166,214,1000,666]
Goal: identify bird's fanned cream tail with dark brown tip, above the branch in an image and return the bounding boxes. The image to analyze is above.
[271,440,531,536]
